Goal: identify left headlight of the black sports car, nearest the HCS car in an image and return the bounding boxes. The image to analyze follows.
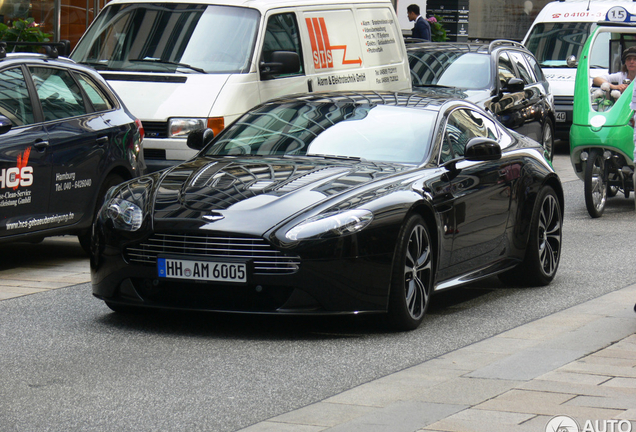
[100,177,153,231]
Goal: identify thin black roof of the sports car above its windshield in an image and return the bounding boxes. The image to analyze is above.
[263,91,474,111]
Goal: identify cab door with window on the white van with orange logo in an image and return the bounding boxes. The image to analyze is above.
[259,11,309,102]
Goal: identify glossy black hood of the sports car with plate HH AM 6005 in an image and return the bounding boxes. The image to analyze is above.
[153,157,412,235]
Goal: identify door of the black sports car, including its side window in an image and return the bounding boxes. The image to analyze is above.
[444,108,513,274]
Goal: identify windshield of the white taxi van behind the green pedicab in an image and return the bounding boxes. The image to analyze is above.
[526,22,609,68]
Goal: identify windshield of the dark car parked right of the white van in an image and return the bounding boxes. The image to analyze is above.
[409,50,491,90]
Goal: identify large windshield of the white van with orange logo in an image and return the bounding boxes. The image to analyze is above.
[71,3,260,73]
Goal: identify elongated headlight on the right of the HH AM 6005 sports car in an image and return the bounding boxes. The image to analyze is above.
[285,210,373,241]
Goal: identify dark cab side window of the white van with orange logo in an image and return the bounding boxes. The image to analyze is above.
[261,13,304,76]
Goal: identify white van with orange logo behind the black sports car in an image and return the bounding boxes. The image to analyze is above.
[71,0,411,171]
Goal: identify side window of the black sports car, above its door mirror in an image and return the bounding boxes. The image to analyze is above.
[441,109,499,162]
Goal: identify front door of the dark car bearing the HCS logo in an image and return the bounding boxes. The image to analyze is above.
[0,66,53,237]
